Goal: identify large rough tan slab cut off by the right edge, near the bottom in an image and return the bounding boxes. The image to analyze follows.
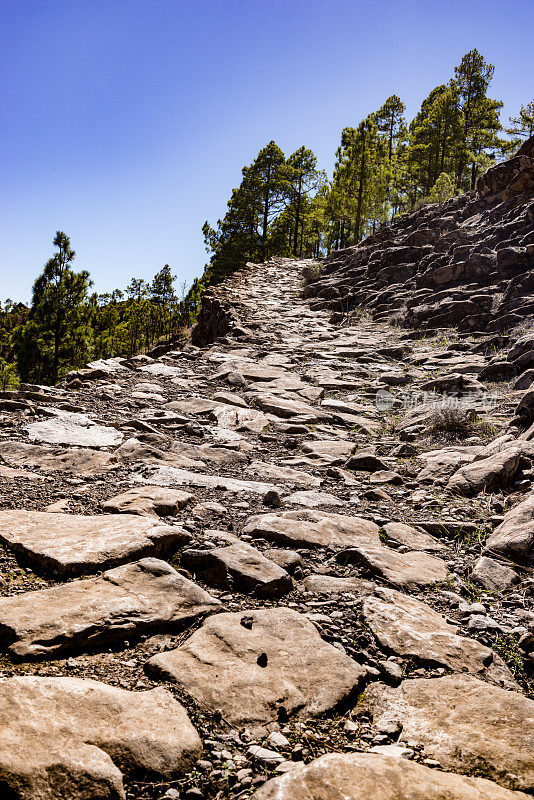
[362,675,534,793]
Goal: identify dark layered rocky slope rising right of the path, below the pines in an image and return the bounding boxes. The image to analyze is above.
[305,137,534,332]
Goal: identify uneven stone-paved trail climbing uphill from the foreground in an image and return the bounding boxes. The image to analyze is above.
[0,253,534,800]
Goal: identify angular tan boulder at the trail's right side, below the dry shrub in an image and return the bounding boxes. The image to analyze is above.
[447,447,521,495]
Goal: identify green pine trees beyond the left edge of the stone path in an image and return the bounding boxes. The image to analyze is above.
[0,231,197,390]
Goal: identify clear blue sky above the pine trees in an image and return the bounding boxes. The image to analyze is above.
[0,0,534,300]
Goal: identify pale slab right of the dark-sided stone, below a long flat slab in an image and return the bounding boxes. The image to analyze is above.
[338,544,448,589]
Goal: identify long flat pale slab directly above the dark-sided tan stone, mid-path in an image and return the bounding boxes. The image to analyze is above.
[243,509,380,548]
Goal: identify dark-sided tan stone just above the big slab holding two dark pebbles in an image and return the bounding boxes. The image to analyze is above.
[181,542,293,597]
